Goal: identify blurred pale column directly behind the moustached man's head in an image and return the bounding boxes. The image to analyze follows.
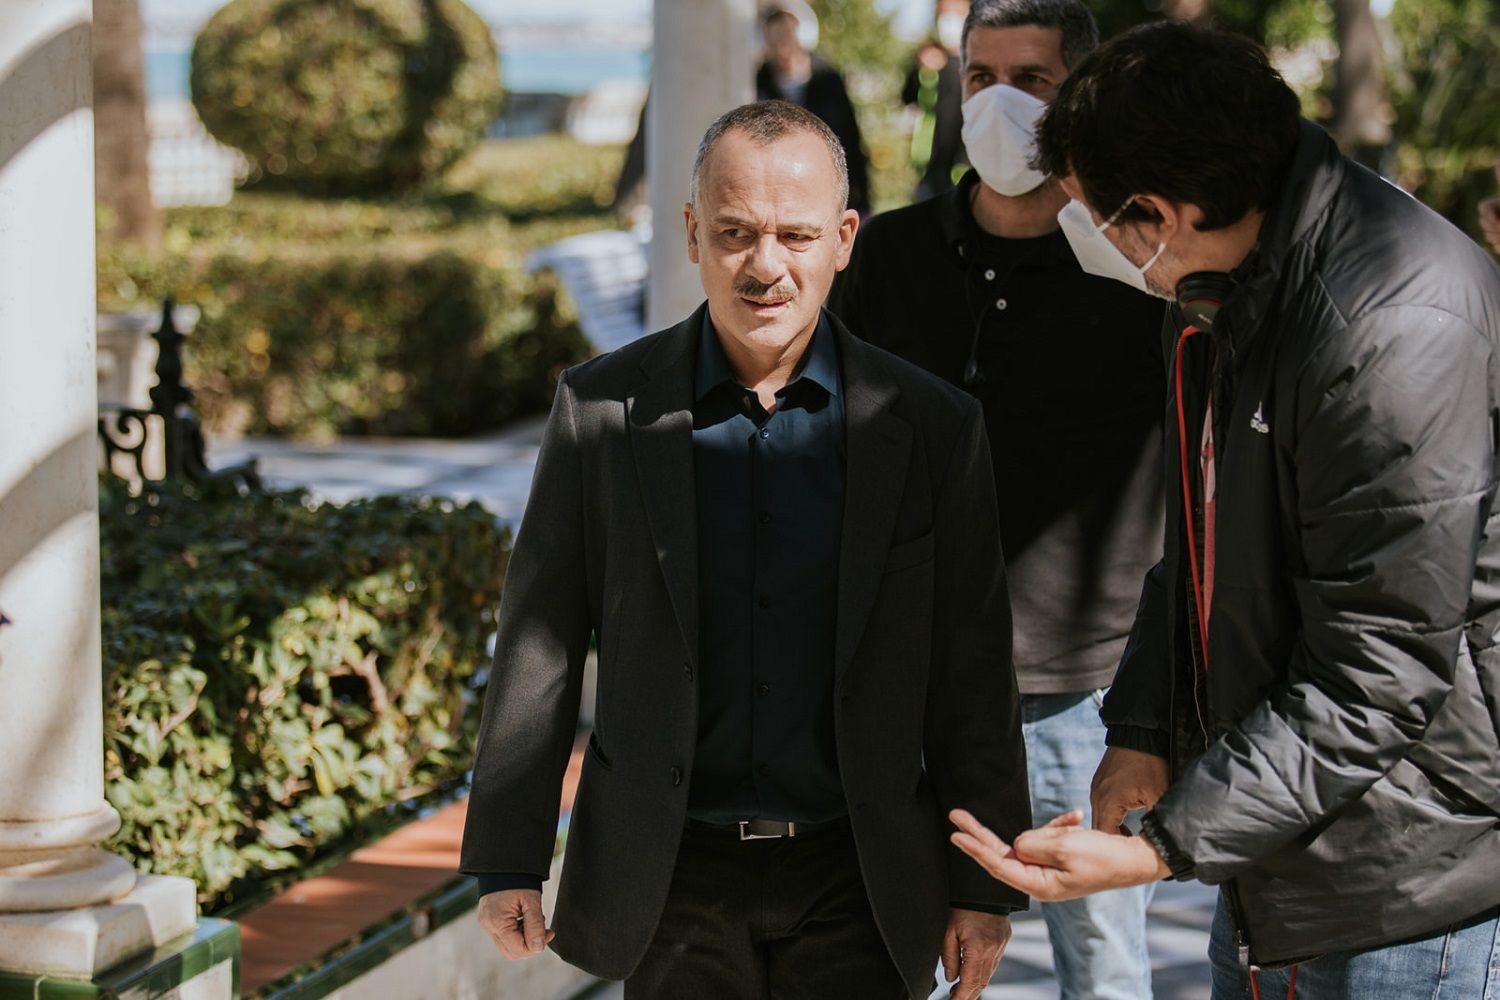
[647,0,756,330]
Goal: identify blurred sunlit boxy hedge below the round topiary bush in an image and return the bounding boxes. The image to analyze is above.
[98,138,621,439]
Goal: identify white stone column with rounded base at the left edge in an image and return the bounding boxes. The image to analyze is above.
[0,0,197,978]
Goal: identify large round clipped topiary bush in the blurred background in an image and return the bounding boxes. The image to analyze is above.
[191,0,501,193]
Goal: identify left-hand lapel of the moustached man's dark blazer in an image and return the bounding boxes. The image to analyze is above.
[626,306,707,667]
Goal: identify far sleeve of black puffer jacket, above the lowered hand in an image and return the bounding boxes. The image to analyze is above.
[1100,562,1172,757]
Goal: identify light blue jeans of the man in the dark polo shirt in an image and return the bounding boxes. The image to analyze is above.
[1022,691,1155,1000]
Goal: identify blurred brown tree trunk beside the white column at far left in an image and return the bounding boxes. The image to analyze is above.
[93,0,162,250]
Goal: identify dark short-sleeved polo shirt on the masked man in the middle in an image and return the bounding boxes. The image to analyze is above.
[828,171,1167,694]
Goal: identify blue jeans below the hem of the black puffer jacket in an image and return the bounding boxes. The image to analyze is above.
[1209,894,1500,1000]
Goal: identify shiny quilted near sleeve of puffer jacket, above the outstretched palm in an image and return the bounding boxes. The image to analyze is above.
[1154,307,1494,882]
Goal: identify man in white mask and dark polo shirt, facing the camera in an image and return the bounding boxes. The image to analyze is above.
[830,0,1166,1000]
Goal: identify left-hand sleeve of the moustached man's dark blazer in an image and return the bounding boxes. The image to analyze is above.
[459,373,591,879]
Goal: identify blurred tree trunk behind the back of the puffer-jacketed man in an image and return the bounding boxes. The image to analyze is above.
[1331,0,1391,168]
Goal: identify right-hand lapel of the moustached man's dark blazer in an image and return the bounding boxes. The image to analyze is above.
[834,321,912,679]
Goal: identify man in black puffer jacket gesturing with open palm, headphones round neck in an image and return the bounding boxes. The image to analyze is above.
[954,22,1500,1000]
